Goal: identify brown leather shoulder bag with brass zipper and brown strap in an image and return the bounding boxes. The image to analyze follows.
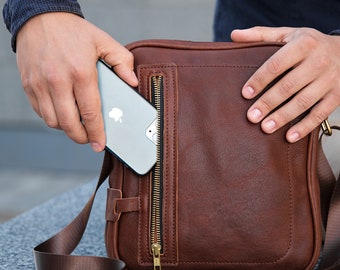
[35,40,340,270]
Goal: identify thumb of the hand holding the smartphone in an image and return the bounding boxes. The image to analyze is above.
[95,33,138,87]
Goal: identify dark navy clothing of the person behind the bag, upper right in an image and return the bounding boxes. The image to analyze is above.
[214,0,340,41]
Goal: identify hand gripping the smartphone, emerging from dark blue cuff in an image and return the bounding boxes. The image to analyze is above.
[16,12,138,151]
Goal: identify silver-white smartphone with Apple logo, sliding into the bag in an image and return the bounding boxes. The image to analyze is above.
[97,60,158,175]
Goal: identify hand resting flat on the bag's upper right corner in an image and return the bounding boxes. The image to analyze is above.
[231,27,340,142]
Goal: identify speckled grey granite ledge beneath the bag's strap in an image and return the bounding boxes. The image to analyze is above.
[0,180,107,270]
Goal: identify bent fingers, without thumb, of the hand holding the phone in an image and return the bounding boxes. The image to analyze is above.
[25,60,105,152]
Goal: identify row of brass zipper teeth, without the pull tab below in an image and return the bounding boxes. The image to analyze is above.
[150,76,162,251]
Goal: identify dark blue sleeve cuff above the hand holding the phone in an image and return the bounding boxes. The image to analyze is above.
[2,0,84,52]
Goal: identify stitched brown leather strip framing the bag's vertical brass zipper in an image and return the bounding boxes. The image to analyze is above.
[137,64,179,270]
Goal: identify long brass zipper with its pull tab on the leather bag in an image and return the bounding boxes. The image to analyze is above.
[150,75,163,270]
